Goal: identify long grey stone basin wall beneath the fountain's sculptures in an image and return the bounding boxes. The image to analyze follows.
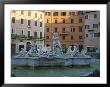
[11,57,91,67]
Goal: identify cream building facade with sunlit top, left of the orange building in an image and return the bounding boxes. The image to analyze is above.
[11,10,45,53]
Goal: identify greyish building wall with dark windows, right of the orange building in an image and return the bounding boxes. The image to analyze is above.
[84,11,100,49]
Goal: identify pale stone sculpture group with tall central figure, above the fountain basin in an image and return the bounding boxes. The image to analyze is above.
[12,33,91,58]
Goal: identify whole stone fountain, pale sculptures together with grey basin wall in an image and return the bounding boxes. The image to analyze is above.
[12,33,91,66]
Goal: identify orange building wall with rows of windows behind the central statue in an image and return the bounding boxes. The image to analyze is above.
[45,10,85,52]
